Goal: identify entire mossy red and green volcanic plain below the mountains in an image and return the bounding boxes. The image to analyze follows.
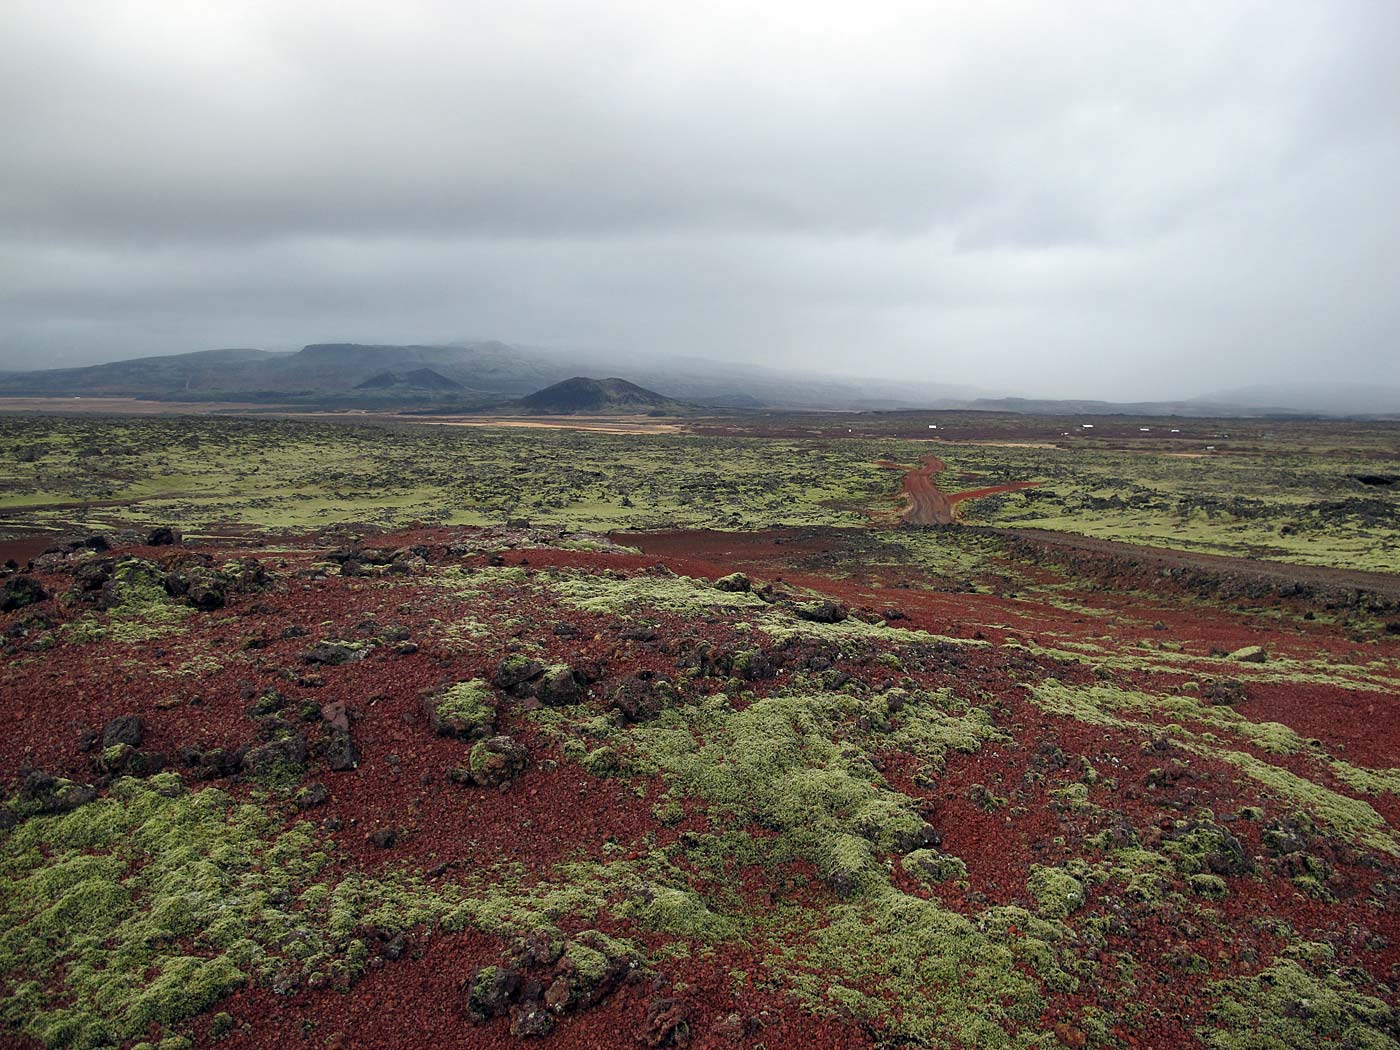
[0,413,1400,1050]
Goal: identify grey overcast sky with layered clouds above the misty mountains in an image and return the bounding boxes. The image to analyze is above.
[0,0,1400,398]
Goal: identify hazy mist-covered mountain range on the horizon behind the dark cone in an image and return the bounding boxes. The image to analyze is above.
[0,340,1400,417]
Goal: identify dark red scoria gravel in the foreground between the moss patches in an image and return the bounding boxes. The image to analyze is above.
[0,529,1400,1050]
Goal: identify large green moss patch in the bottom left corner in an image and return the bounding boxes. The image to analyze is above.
[0,773,448,1047]
